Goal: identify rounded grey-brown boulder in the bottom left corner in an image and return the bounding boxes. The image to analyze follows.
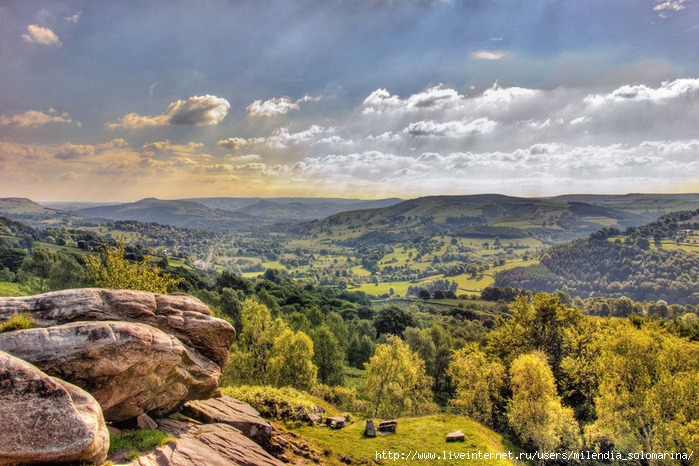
[0,351,109,464]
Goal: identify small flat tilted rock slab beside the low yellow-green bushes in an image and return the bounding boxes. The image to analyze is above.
[183,396,273,445]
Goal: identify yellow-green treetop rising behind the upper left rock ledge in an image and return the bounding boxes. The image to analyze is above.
[84,243,179,293]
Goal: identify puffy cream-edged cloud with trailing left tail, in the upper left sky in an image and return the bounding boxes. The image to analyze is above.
[107,95,231,129]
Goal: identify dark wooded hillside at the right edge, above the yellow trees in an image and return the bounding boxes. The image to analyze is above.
[495,210,699,304]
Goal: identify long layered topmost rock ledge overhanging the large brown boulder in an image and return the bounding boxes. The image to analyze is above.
[0,288,235,370]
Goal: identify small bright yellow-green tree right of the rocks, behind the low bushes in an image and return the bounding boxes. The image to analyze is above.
[267,328,318,390]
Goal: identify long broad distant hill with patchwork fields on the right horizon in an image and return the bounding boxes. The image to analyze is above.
[303,194,699,245]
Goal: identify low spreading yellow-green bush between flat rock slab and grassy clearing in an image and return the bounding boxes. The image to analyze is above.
[221,385,318,421]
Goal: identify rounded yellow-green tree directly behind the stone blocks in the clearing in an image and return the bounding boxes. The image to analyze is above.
[363,335,437,417]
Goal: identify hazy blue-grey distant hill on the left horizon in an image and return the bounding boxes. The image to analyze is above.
[78,198,258,230]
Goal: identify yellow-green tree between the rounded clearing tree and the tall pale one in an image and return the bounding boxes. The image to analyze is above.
[448,343,505,427]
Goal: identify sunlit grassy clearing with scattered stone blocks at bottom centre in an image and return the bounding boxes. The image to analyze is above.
[291,414,519,465]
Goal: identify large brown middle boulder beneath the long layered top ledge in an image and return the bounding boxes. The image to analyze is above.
[0,322,221,421]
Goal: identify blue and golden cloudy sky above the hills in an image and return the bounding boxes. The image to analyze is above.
[0,0,699,202]
